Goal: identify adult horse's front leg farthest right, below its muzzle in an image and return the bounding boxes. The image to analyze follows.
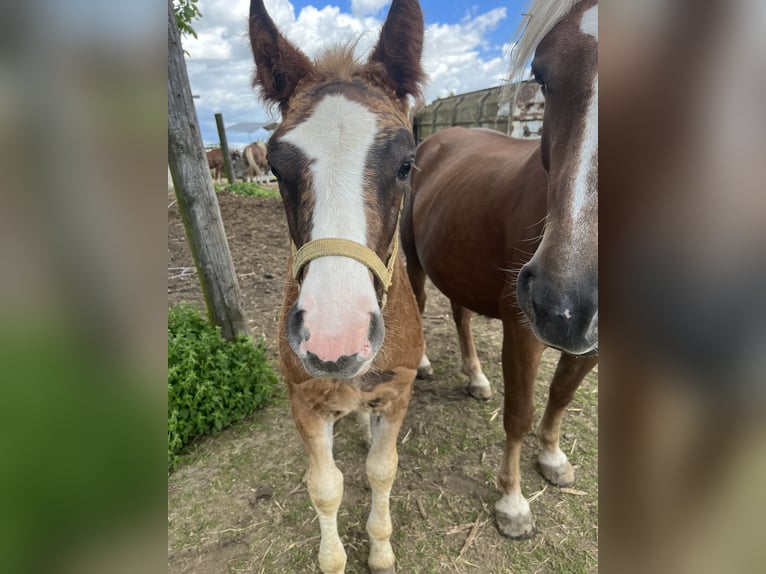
[537,353,598,486]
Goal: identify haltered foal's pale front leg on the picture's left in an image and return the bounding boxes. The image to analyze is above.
[291,397,346,574]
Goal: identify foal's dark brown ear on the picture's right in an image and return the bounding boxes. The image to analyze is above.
[370,0,425,98]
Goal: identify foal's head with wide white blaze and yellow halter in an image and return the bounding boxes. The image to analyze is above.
[250,0,424,377]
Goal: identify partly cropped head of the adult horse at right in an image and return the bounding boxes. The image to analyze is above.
[517,0,598,354]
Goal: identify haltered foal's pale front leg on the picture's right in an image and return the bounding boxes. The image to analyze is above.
[367,382,414,574]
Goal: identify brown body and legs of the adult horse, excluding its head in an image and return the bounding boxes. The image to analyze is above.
[402,128,596,537]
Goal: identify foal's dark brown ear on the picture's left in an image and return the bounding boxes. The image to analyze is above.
[250,0,312,115]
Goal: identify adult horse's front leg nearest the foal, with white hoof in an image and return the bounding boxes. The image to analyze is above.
[495,316,545,538]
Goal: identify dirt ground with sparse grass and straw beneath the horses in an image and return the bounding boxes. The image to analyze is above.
[168,192,598,574]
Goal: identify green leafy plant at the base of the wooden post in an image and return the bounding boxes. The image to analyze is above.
[168,304,277,472]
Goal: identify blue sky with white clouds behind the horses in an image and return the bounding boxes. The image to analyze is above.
[183,0,526,149]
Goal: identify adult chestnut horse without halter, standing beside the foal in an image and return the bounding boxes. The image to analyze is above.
[401,0,598,538]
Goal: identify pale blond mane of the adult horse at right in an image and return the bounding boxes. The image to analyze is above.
[505,0,580,100]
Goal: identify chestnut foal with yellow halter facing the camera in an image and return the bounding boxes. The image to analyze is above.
[250,0,423,573]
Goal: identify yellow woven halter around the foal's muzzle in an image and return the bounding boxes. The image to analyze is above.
[292,196,404,309]
